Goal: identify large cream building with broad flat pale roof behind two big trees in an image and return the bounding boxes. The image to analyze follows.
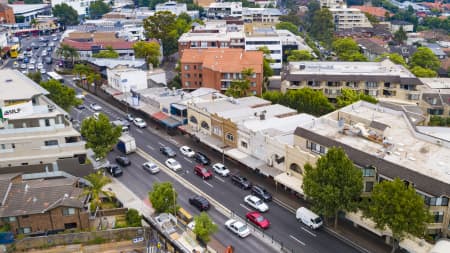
[286,101,450,241]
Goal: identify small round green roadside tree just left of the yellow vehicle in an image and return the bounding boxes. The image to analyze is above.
[148,182,178,214]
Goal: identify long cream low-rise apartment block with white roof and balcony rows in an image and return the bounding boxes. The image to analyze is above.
[281,59,422,103]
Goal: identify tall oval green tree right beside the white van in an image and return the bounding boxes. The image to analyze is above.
[302,147,363,228]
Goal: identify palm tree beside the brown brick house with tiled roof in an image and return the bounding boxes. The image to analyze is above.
[82,170,114,212]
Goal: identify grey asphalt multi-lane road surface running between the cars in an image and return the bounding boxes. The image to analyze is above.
[66,79,358,253]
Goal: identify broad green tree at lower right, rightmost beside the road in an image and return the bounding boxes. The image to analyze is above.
[364,178,431,252]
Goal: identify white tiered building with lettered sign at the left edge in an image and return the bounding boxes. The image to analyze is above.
[0,69,86,170]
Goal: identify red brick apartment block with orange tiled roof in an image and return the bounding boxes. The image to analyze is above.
[180,48,264,95]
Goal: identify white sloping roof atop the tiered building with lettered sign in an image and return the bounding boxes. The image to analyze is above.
[0,69,49,101]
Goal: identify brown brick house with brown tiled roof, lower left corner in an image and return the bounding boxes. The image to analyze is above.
[0,173,89,234]
